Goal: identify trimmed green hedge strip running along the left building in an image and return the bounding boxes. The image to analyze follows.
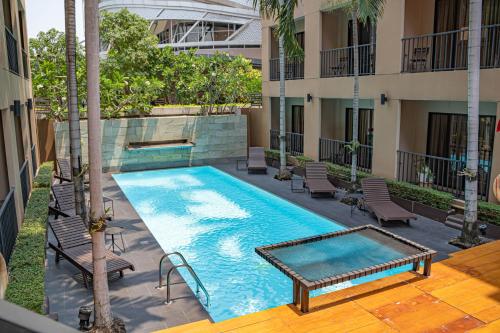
[5,163,53,314]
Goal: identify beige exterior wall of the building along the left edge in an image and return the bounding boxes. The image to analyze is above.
[0,0,38,225]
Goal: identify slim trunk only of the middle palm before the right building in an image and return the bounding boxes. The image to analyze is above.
[351,7,359,183]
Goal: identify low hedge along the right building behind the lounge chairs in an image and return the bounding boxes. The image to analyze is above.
[266,150,500,225]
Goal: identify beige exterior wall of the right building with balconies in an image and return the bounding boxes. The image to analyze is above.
[262,0,500,202]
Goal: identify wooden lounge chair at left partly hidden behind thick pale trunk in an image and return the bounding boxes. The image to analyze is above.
[49,216,135,288]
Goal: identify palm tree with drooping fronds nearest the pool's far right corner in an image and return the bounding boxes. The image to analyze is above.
[253,0,303,179]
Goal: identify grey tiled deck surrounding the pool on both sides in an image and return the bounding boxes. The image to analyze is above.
[46,164,464,332]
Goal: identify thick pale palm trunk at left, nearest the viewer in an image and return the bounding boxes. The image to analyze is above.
[85,0,112,331]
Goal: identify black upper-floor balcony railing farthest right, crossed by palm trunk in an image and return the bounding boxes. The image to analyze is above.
[401,24,500,73]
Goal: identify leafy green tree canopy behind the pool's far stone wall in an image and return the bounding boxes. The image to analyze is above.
[30,9,261,119]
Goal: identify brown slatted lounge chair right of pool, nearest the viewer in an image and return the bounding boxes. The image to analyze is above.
[361,178,417,225]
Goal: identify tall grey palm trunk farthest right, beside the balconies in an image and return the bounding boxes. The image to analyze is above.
[460,0,482,247]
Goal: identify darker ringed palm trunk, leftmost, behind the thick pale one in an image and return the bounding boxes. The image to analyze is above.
[64,0,87,221]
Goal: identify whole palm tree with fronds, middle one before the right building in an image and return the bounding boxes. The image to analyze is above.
[325,0,385,183]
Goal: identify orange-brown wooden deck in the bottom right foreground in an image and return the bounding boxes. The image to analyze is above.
[159,241,500,333]
